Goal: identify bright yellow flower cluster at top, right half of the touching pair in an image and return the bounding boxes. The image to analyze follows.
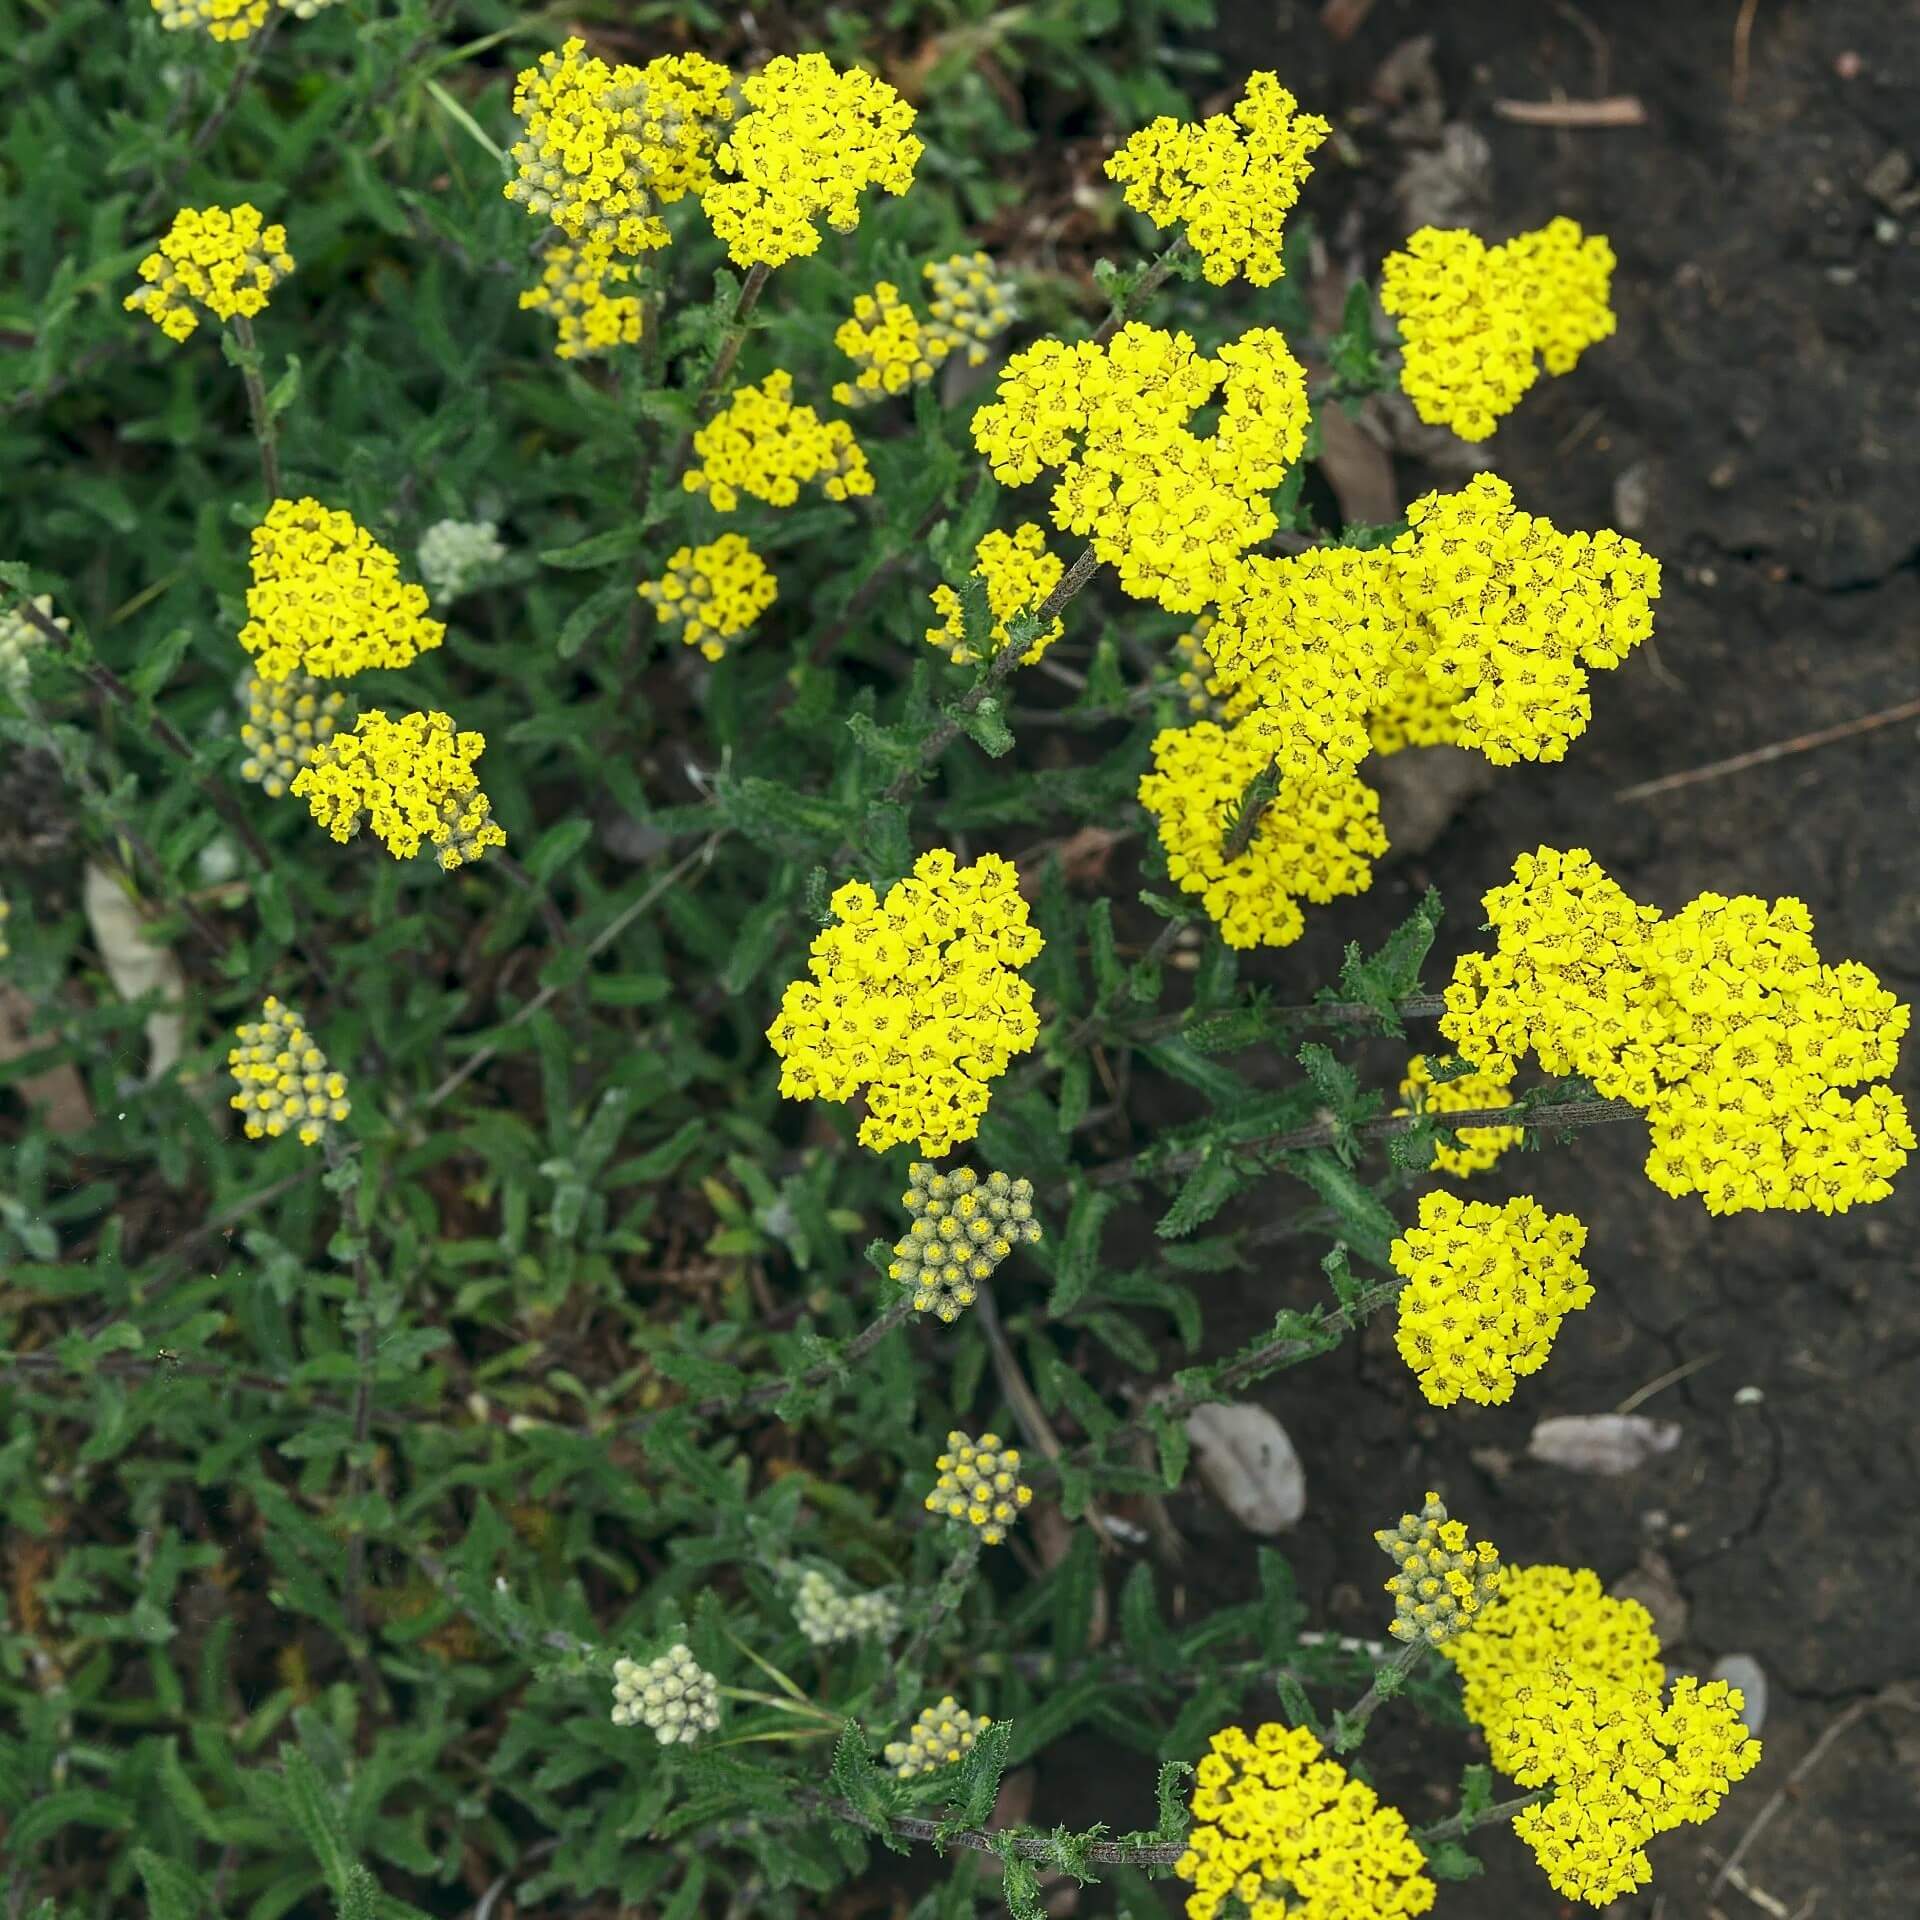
[701,54,922,267]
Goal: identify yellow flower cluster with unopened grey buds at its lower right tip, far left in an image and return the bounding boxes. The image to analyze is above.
[292,707,507,872]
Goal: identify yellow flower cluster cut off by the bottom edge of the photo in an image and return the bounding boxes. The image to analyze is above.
[1173,1722,1434,1920]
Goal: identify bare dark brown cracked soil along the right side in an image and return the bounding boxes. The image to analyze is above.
[1035,0,1920,1920]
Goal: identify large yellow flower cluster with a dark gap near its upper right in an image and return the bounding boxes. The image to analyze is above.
[973,321,1308,612]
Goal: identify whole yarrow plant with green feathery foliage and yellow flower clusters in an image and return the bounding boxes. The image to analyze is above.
[0,22,1889,1920]
